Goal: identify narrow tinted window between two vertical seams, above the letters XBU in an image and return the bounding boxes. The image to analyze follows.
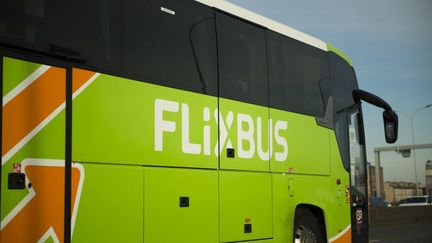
[217,13,268,106]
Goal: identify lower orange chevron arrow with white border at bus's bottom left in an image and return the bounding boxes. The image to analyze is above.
[1,166,83,243]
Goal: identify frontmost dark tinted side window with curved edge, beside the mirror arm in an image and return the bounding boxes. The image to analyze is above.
[329,52,358,112]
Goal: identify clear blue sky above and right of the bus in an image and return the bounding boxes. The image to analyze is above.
[230,0,432,184]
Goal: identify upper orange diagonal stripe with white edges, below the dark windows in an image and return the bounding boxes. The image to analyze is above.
[2,67,95,156]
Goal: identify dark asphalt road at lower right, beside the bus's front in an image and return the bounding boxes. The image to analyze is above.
[369,222,432,243]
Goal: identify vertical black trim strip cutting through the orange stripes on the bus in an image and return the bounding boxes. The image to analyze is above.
[64,65,72,243]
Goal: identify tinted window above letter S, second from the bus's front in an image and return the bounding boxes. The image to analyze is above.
[268,31,330,116]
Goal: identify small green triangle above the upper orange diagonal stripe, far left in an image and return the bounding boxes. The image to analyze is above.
[3,57,41,96]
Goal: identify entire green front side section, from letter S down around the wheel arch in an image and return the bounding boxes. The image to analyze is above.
[271,110,351,242]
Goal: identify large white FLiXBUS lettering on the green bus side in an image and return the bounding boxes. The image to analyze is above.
[154,99,288,161]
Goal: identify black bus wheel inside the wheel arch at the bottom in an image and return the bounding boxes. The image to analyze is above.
[294,208,325,243]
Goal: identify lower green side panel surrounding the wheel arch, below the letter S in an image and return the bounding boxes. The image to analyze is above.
[273,174,351,242]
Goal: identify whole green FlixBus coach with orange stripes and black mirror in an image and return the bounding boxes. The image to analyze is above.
[0,0,398,243]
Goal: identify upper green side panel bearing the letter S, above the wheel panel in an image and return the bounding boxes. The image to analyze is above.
[270,109,330,175]
